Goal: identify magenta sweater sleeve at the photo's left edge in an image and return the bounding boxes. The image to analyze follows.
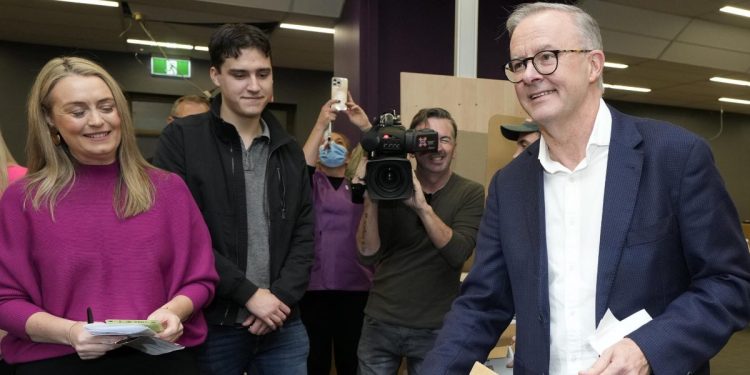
[0,183,43,339]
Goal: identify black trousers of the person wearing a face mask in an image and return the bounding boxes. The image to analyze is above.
[300,290,368,375]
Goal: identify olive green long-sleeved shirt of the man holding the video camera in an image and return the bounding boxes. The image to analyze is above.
[359,173,484,329]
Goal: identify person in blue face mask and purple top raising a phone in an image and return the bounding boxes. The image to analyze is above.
[300,96,372,375]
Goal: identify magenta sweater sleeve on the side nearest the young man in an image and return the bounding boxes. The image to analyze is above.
[157,174,218,311]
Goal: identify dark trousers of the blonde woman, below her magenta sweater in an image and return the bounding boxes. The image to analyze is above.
[16,347,199,375]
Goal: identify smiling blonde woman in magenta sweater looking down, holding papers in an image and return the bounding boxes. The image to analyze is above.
[0,57,217,375]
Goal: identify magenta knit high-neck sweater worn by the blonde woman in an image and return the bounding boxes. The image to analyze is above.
[0,163,218,363]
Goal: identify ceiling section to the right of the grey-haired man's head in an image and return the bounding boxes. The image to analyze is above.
[579,0,750,114]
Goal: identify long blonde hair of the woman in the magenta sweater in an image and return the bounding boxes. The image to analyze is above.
[26,57,154,218]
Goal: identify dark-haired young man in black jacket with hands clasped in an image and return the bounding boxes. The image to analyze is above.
[154,24,314,375]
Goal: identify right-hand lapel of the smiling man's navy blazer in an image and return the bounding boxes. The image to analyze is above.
[596,107,643,325]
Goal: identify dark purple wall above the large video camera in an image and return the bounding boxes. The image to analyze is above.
[334,0,455,129]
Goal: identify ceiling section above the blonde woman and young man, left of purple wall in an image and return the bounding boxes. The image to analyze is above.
[0,0,344,71]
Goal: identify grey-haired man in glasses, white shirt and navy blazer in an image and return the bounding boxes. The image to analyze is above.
[422,3,750,375]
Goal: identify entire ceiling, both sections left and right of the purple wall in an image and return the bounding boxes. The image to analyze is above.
[0,0,750,114]
